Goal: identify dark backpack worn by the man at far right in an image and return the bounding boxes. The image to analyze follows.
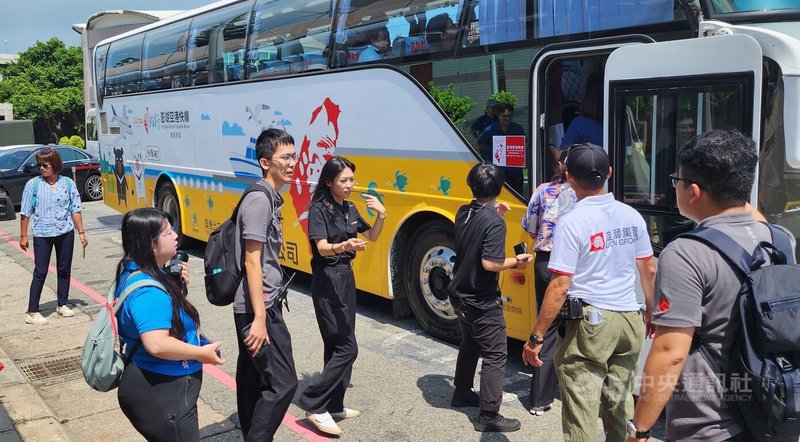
[681,225,800,441]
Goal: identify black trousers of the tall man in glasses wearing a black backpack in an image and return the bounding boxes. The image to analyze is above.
[239,302,297,442]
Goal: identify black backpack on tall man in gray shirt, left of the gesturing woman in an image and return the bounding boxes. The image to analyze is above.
[203,183,272,306]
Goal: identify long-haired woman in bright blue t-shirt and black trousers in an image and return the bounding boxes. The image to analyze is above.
[116,208,224,441]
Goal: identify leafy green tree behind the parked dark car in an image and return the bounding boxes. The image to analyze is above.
[0,37,83,143]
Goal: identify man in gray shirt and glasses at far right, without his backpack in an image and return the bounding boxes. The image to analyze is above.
[628,131,794,442]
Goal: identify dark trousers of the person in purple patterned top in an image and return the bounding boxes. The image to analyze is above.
[530,252,559,407]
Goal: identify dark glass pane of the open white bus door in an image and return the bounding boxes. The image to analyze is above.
[618,80,749,246]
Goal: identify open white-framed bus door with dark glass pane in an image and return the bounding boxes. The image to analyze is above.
[603,35,762,384]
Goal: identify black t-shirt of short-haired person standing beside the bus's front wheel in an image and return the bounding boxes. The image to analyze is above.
[450,201,506,304]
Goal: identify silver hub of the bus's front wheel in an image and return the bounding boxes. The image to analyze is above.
[419,246,456,320]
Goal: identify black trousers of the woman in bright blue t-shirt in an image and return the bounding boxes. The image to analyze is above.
[117,364,203,442]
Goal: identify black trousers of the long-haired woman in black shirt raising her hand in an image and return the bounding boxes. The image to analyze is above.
[298,264,358,414]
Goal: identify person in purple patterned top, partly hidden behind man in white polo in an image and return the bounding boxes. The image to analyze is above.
[522,150,576,416]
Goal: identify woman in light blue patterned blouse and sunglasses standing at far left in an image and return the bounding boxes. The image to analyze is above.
[19,147,89,325]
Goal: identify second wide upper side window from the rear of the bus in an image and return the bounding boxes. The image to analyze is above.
[142,20,189,91]
